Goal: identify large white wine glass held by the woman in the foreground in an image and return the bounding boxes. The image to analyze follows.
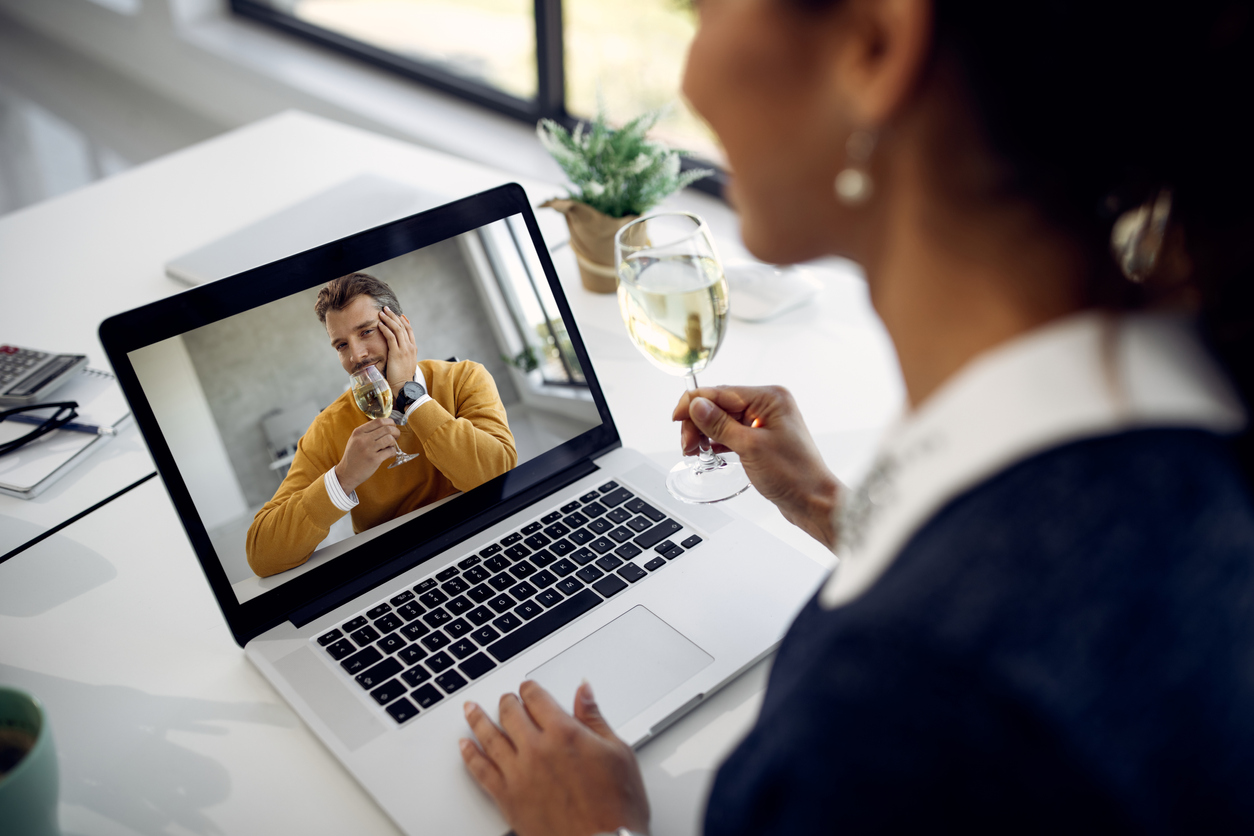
[614,212,749,503]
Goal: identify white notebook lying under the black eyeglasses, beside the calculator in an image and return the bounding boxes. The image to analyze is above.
[0,368,130,499]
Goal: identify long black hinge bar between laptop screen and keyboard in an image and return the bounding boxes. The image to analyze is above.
[288,459,599,627]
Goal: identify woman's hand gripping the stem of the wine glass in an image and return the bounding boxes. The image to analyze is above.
[671,386,841,548]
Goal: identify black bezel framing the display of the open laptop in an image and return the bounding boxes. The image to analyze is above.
[100,183,621,647]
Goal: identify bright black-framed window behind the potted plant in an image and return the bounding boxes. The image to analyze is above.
[231,0,722,191]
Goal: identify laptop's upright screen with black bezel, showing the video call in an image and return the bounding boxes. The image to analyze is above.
[102,187,617,637]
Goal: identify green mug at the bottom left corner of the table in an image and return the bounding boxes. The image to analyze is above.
[0,687,61,836]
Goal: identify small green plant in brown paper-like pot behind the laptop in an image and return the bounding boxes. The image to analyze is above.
[535,108,714,293]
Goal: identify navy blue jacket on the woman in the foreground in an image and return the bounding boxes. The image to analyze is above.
[705,430,1254,836]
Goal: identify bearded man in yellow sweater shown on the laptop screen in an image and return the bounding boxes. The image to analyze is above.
[247,273,518,577]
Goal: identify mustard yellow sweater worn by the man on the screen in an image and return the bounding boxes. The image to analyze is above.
[246,360,518,577]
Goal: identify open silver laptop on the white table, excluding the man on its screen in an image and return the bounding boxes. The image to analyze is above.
[100,184,824,836]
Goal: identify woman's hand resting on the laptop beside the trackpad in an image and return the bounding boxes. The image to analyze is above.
[461,682,648,836]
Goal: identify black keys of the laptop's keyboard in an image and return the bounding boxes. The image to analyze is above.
[311,481,701,723]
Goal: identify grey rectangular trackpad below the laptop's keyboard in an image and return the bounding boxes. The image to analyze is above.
[527,607,714,729]
